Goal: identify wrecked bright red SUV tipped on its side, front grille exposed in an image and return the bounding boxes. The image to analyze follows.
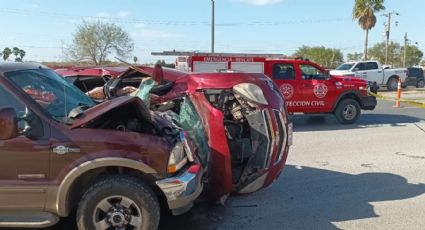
[60,66,292,201]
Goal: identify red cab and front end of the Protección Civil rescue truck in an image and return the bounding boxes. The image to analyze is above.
[265,59,376,124]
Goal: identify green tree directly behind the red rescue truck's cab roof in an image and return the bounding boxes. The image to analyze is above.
[294,46,344,68]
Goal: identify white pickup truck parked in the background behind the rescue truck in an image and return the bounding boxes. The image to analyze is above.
[330,61,407,90]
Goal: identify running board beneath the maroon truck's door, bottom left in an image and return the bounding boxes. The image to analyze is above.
[0,212,59,228]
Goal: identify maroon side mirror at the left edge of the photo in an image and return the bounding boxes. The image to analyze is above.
[0,108,18,140]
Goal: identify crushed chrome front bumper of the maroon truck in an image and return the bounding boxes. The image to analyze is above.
[156,164,203,215]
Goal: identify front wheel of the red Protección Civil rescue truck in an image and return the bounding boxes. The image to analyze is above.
[335,99,360,124]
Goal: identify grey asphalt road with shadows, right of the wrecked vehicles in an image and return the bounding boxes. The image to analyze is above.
[11,98,425,230]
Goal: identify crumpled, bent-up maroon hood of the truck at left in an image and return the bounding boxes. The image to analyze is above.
[71,96,143,129]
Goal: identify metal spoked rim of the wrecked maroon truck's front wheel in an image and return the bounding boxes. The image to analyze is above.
[93,196,142,230]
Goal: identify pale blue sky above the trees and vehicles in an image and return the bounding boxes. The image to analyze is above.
[0,0,425,63]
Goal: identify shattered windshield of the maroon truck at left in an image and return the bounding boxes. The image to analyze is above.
[5,69,95,120]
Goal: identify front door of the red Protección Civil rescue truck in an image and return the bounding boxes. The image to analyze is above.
[298,63,337,113]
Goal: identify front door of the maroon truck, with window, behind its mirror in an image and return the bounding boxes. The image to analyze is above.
[0,82,50,212]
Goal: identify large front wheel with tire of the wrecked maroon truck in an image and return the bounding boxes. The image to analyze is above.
[77,176,160,230]
